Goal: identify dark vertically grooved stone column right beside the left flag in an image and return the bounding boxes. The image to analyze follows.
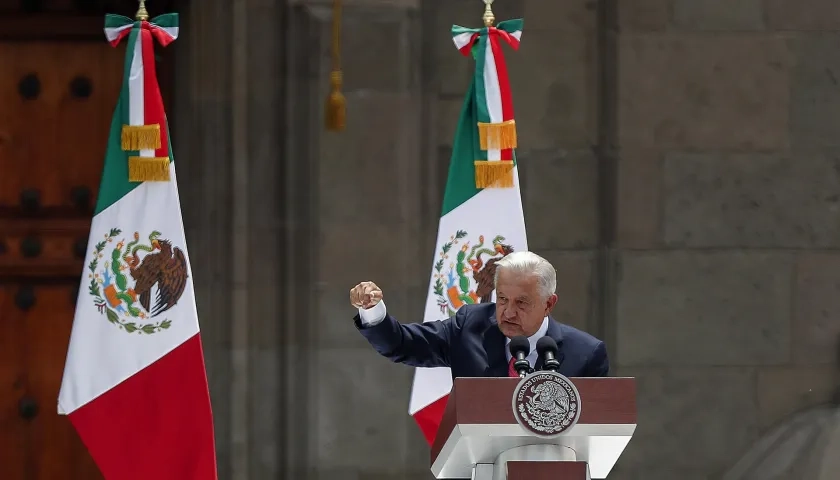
[172,0,288,480]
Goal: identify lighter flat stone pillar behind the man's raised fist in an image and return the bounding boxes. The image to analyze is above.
[284,1,436,478]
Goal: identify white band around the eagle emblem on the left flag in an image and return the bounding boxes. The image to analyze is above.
[58,163,199,415]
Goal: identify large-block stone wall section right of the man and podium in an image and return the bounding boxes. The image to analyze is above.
[613,0,840,480]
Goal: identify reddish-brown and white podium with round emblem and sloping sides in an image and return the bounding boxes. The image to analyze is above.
[431,372,636,480]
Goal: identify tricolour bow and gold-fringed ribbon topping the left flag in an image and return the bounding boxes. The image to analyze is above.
[105,13,178,182]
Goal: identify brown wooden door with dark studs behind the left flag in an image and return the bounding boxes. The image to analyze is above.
[0,17,125,480]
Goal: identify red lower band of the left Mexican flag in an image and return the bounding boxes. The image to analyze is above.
[68,334,218,480]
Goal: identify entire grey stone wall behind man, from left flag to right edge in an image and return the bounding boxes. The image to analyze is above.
[170,0,840,480]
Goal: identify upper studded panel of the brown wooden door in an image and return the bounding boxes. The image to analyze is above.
[0,41,125,214]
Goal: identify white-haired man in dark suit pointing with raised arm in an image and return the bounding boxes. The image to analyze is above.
[350,252,609,379]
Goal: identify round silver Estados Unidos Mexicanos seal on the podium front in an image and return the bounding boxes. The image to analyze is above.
[513,371,580,437]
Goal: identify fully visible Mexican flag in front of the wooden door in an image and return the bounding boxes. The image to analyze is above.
[58,14,217,480]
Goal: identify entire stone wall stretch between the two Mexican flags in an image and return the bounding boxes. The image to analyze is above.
[174,0,426,480]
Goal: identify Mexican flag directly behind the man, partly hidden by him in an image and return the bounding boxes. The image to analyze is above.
[408,20,528,444]
